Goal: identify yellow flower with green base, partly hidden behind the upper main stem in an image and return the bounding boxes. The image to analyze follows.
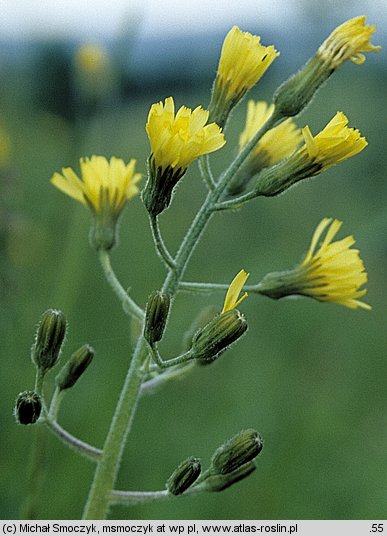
[228,100,302,195]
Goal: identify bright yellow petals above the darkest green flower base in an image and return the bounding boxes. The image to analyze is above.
[146,97,226,170]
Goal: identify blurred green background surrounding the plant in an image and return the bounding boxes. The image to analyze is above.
[0,0,387,519]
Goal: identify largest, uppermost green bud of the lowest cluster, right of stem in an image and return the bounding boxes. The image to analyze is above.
[211,430,263,475]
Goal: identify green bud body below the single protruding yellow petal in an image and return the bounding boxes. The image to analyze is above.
[192,309,247,362]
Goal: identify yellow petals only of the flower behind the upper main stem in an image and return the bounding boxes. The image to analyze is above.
[239,100,302,171]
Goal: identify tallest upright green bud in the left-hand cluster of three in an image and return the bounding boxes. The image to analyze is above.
[31,309,67,373]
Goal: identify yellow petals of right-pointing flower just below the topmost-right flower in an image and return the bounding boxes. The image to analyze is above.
[300,112,368,171]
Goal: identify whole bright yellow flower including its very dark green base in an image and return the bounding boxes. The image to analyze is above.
[142,97,226,216]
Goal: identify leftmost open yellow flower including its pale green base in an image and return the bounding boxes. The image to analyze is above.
[51,156,141,249]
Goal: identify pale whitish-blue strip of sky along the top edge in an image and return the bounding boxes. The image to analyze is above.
[0,0,387,39]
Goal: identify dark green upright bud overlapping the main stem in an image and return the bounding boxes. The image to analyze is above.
[144,290,171,344]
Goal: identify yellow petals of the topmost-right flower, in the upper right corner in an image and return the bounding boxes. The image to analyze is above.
[317,16,381,69]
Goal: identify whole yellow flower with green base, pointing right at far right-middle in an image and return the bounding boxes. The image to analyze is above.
[259,218,371,310]
